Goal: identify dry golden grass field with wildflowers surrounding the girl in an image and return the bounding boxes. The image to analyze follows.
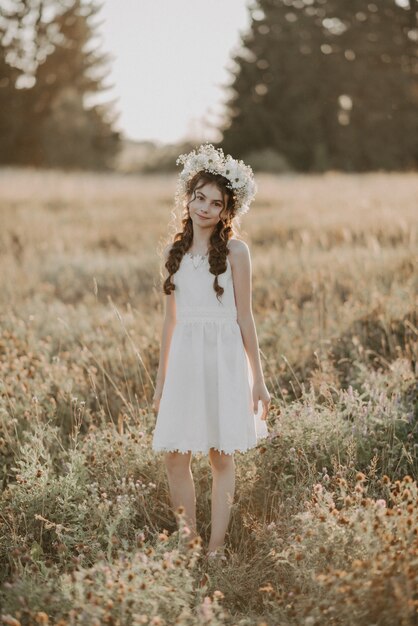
[0,169,418,626]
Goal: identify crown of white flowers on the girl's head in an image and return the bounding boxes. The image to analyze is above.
[176,143,257,215]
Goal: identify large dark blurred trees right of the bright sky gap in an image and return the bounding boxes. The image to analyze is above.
[221,0,418,171]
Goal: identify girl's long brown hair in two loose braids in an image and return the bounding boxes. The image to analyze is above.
[163,171,236,300]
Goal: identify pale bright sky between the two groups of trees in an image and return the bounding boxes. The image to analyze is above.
[95,0,250,143]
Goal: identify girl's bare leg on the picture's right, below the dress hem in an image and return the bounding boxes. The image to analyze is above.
[208,448,235,551]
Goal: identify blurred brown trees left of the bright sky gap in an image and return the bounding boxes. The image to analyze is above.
[0,0,121,169]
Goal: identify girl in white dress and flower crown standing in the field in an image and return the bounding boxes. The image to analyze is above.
[152,144,270,559]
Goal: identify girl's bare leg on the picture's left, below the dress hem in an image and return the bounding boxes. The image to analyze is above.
[164,452,198,539]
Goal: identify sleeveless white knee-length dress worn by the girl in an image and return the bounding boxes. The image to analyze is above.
[152,246,268,454]
